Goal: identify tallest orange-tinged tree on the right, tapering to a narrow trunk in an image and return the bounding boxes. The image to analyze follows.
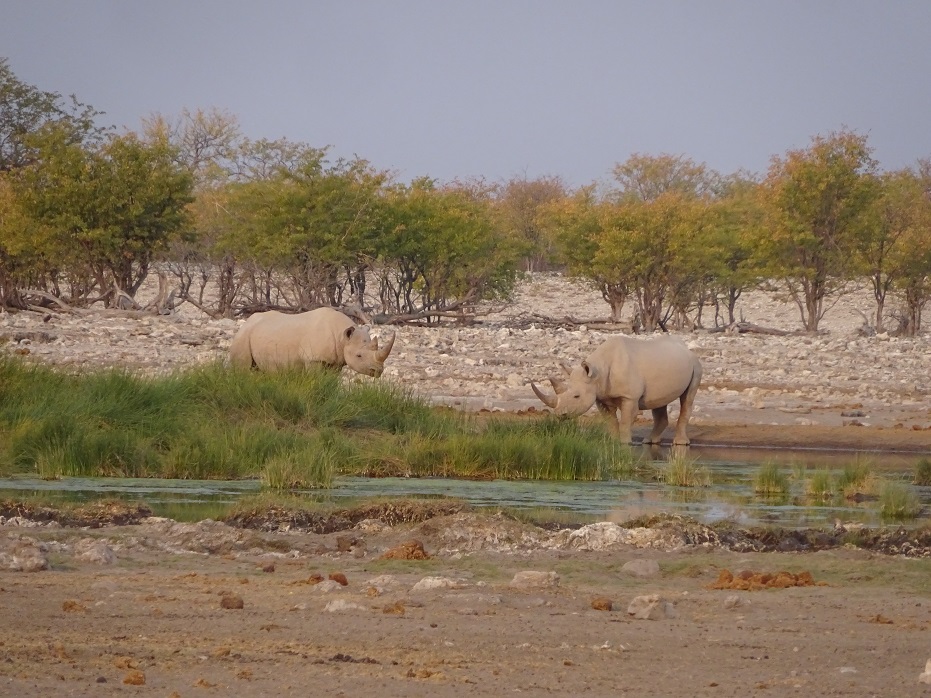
[758,131,876,332]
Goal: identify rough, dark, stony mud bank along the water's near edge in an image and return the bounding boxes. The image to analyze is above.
[0,500,931,557]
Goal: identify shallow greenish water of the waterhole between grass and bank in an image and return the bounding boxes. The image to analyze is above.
[0,447,931,527]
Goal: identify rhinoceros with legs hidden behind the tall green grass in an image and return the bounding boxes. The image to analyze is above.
[230,308,394,378]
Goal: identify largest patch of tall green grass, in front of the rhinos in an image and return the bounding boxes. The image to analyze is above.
[0,359,635,489]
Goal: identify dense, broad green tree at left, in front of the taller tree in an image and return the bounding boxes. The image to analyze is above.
[12,124,191,299]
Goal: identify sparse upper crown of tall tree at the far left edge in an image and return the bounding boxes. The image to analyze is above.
[0,58,106,172]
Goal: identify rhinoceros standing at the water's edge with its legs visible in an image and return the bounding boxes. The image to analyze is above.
[530,337,701,446]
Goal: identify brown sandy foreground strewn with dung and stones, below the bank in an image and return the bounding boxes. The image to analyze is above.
[0,508,931,696]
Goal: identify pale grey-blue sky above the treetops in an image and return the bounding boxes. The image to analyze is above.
[0,0,931,186]
